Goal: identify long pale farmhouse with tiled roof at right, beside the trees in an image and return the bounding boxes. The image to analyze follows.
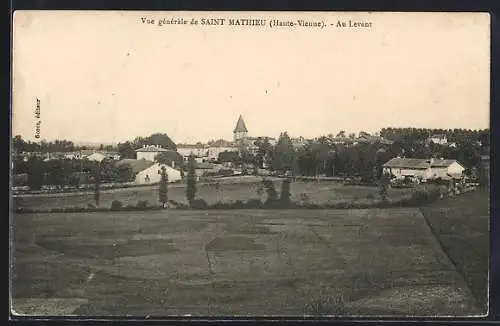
[382,157,465,180]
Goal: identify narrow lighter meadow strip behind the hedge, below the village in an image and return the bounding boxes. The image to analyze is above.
[15,181,422,209]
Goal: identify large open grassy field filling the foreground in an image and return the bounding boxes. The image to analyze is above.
[12,208,482,316]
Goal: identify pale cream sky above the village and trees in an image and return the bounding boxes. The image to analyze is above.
[12,11,490,143]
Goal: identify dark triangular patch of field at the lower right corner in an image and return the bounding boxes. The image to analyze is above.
[420,190,490,312]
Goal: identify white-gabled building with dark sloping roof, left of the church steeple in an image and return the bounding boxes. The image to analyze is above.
[116,159,181,185]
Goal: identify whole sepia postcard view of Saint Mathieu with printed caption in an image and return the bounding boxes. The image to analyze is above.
[9,10,490,318]
